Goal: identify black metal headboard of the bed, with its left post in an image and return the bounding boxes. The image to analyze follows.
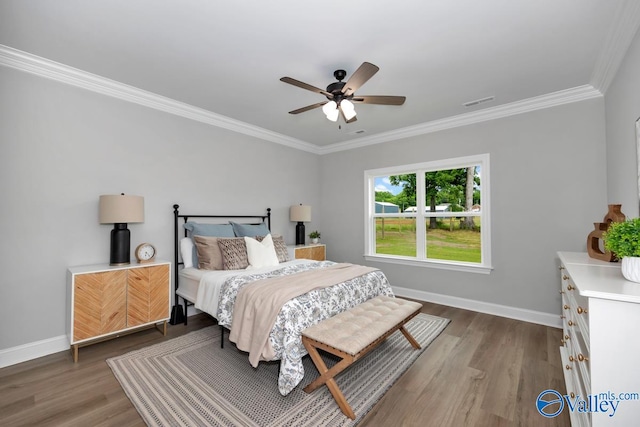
[169,205,271,325]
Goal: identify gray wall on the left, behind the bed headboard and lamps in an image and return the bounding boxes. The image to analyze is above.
[0,67,320,350]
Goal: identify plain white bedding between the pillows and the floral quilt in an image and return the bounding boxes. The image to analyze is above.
[177,259,314,319]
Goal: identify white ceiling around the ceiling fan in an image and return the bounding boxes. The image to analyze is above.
[0,0,640,152]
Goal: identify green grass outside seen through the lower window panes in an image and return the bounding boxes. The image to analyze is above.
[376,218,481,263]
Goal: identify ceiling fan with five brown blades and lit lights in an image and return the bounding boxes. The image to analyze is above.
[280,62,406,123]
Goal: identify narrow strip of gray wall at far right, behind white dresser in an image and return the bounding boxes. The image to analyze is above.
[605,28,640,217]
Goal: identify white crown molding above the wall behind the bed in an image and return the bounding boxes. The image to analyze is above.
[0,45,318,154]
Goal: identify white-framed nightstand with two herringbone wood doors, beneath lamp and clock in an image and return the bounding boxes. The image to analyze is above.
[67,261,171,362]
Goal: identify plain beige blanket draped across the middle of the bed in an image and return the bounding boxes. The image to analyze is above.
[229,264,377,368]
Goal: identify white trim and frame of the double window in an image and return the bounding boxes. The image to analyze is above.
[364,153,493,274]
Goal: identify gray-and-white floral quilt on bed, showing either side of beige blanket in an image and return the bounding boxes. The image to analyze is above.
[216,261,393,396]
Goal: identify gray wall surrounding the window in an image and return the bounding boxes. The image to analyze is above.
[321,98,607,313]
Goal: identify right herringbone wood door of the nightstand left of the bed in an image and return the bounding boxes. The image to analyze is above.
[127,265,169,327]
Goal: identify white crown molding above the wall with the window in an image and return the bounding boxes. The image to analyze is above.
[320,85,602,154]
